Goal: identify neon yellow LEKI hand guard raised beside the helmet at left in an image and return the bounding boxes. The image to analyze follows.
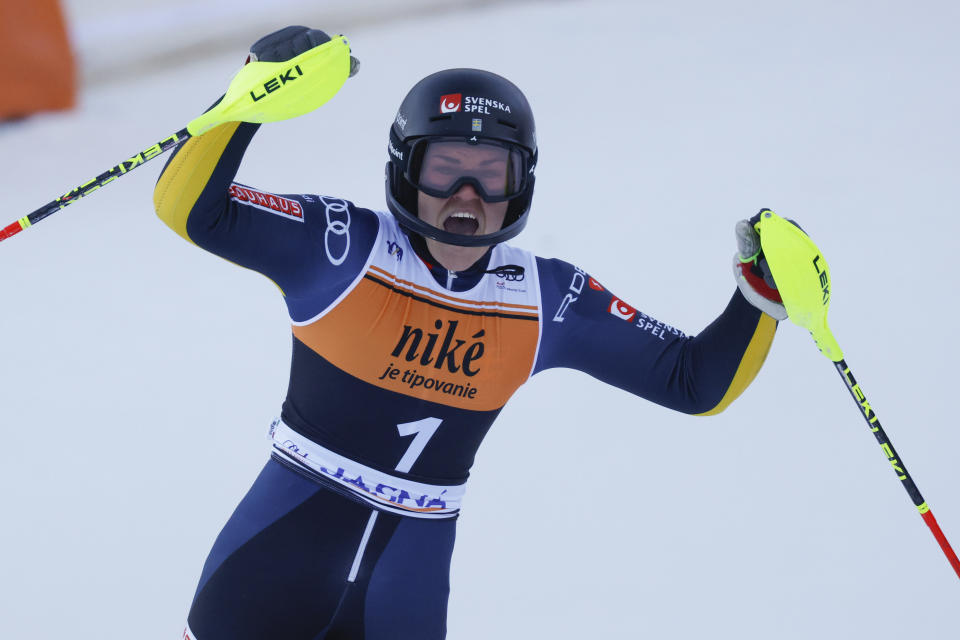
[187,36,350,136]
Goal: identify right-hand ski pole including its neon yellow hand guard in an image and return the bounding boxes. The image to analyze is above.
[755,209,960,577]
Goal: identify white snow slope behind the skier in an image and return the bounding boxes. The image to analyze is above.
[0,0,960,640]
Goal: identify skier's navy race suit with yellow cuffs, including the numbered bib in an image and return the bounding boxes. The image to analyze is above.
[155,123,776,640]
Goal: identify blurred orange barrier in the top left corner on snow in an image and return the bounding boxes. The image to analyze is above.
[0,0,76,120]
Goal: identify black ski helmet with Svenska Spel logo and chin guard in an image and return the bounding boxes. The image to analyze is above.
[386,69,537,247]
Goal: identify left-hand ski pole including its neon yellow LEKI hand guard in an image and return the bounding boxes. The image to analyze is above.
[0,36,359,241]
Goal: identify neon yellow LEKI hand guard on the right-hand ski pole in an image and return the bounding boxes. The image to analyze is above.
[755,209,843,362]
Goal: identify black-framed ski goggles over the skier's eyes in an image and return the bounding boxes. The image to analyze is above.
[404,138,532,202]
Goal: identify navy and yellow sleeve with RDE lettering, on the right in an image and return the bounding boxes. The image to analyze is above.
[535,258,777,415]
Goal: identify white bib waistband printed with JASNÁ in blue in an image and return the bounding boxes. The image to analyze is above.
[270,418,466,518]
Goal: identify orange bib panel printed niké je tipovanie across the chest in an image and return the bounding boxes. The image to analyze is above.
[293,267,539,411]
